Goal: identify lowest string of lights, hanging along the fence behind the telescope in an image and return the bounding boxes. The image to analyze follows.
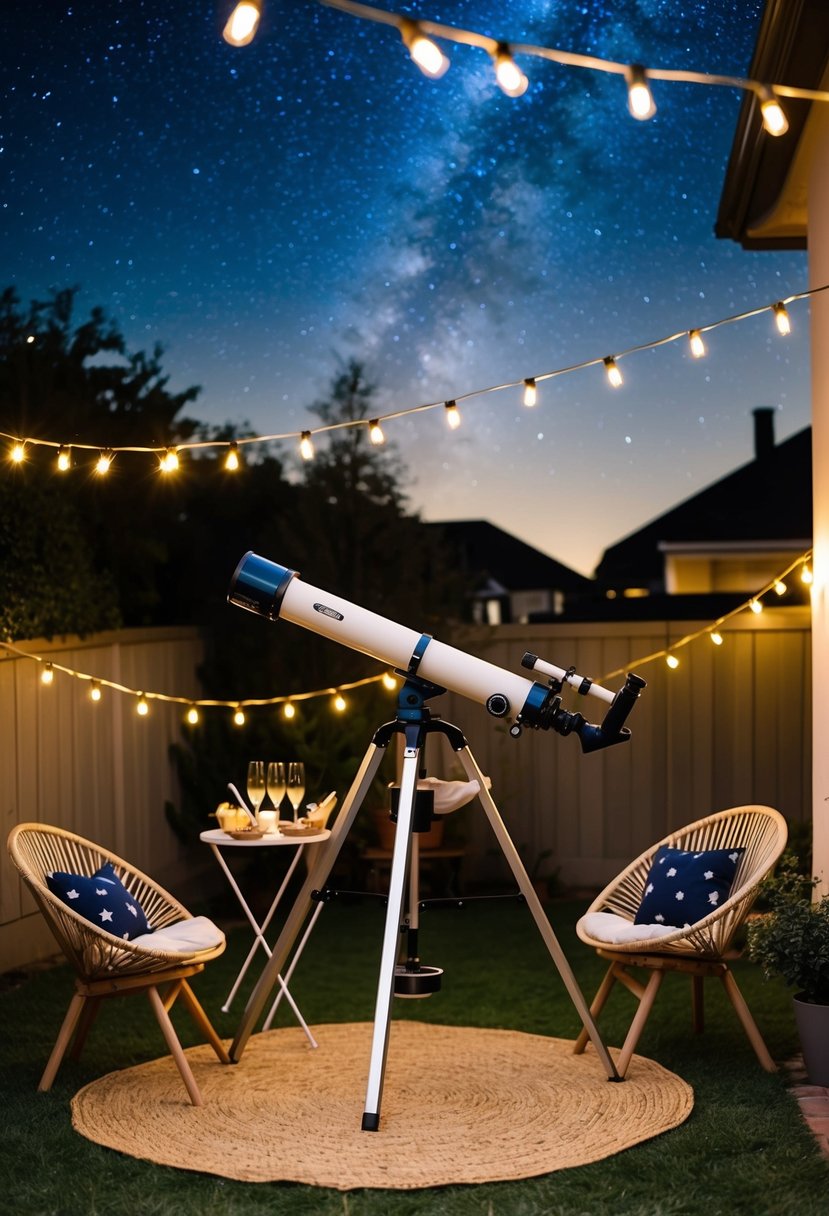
[0,548,812,714]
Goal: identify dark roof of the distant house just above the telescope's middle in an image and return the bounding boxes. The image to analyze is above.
[428,519,593,593]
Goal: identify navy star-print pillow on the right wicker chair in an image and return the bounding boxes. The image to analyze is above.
[633,845,745,929]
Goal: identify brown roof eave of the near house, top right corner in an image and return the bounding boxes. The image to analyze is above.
[714,0,829,249]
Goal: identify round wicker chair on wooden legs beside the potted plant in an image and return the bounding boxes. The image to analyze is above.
[574,806,786,1076]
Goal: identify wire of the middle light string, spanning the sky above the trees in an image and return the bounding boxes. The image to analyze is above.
[0,286,829,472]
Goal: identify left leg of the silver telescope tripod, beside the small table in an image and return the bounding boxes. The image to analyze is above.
[230,743,385,1064]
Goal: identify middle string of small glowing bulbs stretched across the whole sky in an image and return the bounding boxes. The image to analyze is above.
[0,283,829,472]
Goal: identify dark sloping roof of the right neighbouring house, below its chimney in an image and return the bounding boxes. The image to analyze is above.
[596,427,812,587]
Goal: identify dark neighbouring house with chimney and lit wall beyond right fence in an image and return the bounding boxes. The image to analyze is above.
[596,407,812,618]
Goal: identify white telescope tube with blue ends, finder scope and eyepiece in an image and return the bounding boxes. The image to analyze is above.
[227,552,645,753]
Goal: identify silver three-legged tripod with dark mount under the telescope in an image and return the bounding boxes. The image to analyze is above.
[230,672,621,1131]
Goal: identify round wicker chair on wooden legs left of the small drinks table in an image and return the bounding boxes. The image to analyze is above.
[9,823,230,1107]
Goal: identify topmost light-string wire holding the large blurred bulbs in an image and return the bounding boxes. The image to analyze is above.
[317,0,829,101]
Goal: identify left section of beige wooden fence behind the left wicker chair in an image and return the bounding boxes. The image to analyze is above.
[0,629,202,972]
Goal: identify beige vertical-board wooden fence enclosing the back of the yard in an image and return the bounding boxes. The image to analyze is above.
[0,608,811,970]
